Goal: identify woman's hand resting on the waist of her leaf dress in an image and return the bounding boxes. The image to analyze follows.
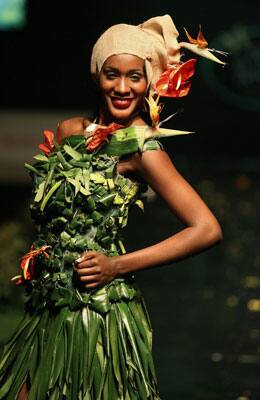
[74,251,117,289]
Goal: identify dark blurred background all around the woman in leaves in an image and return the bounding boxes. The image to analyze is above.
[0,0,260,400]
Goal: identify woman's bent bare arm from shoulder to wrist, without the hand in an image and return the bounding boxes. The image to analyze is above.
[117,150,222,274]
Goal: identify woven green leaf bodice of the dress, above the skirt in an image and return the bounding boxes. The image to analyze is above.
[23,130,162,307]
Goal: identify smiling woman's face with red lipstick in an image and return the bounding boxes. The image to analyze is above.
[99,54,147,123]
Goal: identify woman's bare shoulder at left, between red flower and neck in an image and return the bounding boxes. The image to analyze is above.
[56,117,91,142]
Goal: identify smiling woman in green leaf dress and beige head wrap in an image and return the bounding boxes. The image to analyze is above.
[0,16,221,400]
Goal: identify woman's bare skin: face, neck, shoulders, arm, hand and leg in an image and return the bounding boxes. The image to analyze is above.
[17,54,222,400]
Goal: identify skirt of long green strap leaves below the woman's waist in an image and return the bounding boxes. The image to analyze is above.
[0,280,160,400]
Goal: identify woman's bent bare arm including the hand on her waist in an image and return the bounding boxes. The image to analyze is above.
[75,150,222,288]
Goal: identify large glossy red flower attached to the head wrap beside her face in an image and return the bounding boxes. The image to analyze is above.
[155,58,197,97]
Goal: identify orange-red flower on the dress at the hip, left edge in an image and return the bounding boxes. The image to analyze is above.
[12,245,51,285]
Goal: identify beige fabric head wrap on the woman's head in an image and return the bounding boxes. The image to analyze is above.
[91,15,180,89]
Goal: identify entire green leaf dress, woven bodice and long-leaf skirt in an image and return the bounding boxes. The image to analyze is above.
[0,127,160,400]
